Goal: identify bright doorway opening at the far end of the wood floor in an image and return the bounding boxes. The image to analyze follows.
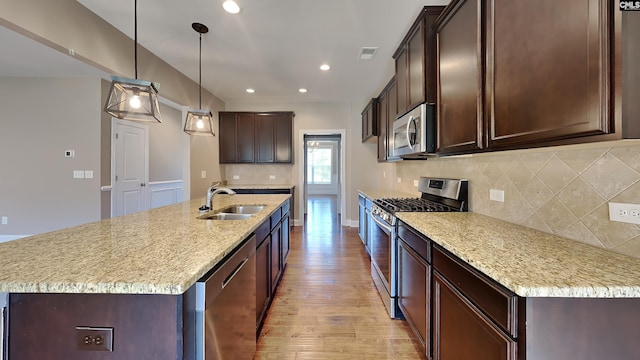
[300,130,344,232]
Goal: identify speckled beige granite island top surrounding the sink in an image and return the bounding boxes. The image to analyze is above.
[0,194,290,295]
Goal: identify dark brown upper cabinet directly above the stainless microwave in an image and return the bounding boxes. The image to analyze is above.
[393,6,444,120]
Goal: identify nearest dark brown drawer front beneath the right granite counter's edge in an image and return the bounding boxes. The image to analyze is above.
[433,246,518,338]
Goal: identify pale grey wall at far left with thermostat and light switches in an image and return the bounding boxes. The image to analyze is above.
[0,78,102,235]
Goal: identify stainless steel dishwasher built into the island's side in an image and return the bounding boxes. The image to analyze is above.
[184,235,256,360]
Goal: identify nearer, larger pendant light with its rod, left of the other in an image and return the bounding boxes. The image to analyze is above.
[104,0,162,122]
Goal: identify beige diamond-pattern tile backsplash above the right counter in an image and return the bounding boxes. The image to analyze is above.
[396,141,640,258]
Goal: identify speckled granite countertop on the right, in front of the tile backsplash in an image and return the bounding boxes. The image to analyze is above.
[397,213,640,298]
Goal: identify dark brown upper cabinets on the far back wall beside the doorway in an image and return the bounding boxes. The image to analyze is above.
[219,111,295,164]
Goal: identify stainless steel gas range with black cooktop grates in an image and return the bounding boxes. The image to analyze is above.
[368,177,468,318]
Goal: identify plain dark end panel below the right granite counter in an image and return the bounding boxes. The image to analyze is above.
[519,298,640,360]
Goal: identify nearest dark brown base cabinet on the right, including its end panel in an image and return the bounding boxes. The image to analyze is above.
[424,245,640,360]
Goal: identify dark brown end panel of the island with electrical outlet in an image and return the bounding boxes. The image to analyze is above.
[7,294,182,360]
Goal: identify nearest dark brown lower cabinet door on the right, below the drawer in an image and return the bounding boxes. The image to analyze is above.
[433,271,517,360]
